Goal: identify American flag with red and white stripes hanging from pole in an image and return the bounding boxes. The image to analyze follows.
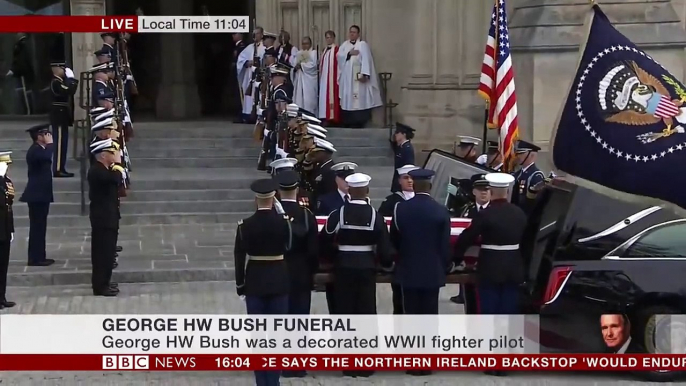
[479,0,519,171]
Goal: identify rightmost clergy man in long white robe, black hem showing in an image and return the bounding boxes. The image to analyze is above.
[337,25,383,127]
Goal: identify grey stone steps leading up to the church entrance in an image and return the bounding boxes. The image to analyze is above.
[0,122,393,285]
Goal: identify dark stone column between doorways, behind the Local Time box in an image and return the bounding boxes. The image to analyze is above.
[155,0,201,119]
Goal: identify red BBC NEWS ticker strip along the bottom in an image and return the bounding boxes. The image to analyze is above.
[0,354,686,371]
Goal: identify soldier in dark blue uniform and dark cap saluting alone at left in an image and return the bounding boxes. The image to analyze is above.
[19,125,55,266]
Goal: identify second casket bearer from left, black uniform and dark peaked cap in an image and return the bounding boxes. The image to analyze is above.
[276,171,319,315]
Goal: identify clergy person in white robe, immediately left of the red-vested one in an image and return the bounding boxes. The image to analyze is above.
[293,37,318,117]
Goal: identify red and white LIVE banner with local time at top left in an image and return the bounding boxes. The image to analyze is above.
[0,16,250,33]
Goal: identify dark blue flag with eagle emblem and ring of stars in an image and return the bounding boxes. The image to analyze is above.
[552,5,686,208]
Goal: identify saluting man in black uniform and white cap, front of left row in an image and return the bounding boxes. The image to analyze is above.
[88,139,124,296]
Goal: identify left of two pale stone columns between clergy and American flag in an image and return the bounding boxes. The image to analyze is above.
[408,0,436,85]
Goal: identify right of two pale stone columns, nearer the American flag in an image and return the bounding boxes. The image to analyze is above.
[438,0,460,85]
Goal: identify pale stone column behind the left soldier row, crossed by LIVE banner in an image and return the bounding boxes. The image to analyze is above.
[69,0,105,120]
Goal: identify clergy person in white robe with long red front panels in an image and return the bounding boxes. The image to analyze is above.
[317,31,341,125]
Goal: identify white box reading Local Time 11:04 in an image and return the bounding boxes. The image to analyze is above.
[137,16,250,33]
